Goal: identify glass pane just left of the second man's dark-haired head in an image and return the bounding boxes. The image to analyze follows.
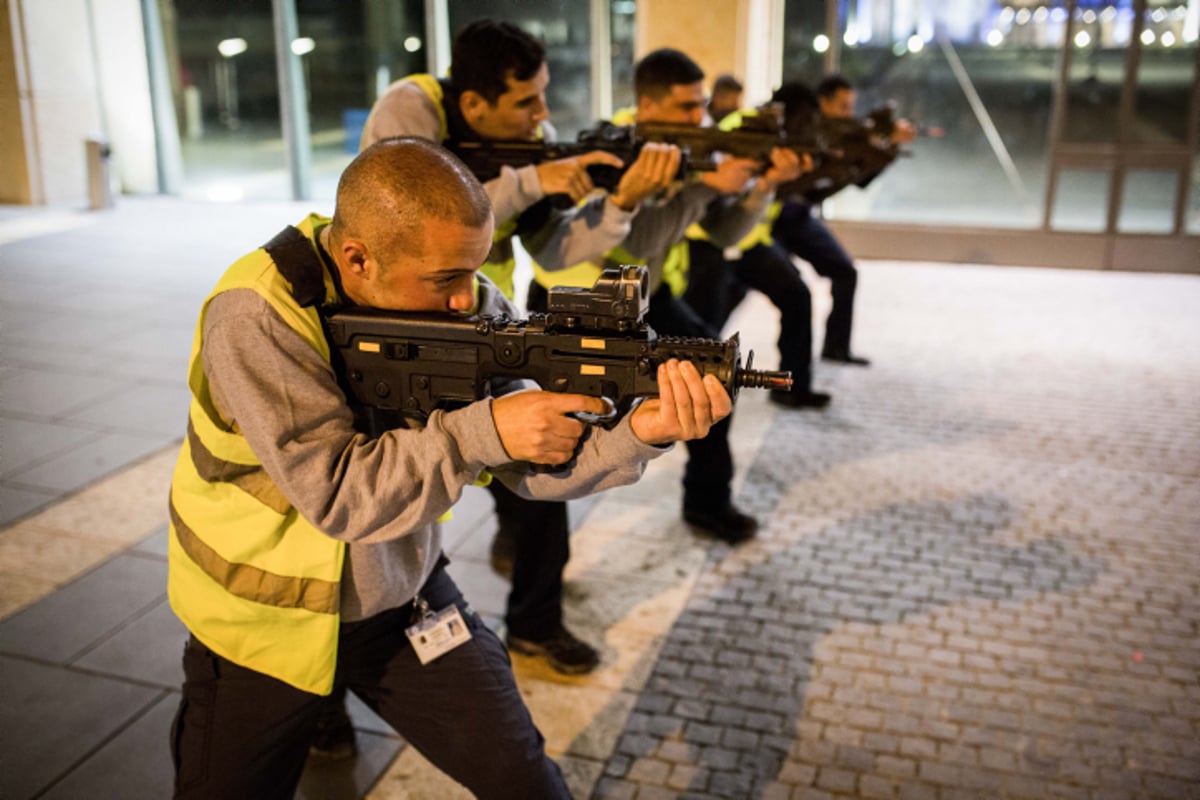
[293,0,426,200]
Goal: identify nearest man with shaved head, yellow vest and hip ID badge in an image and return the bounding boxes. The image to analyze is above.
[168,138,731,800]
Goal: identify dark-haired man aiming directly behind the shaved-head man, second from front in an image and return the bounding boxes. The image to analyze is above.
[355,19,680,686]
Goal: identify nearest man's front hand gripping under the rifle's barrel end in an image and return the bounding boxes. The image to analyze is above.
[629,359,733,445]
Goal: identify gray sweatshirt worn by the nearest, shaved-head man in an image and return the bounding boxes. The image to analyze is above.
[207,277,668,621]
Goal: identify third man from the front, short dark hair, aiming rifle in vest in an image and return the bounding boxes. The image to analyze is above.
[529,48,800,543]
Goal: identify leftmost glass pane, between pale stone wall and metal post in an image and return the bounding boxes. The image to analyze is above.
[162,0,292,201]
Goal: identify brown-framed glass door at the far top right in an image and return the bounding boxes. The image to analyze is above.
[1045,0,1196,235]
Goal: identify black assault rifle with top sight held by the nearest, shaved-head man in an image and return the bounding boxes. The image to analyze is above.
[326,266,792,428]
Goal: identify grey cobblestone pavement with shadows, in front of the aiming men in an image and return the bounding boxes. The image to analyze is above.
[593,264,1200,800]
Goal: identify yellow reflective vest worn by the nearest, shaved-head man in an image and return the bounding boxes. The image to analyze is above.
[167,215,346,694]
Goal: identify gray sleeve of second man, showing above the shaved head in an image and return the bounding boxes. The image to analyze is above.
[359,80,544,225]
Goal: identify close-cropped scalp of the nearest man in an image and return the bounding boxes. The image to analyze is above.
[330,137,492,258]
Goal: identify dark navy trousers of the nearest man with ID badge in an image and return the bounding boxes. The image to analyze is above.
[170,569,570,800]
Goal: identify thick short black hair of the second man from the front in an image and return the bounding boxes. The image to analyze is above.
[450,19,546,104]
